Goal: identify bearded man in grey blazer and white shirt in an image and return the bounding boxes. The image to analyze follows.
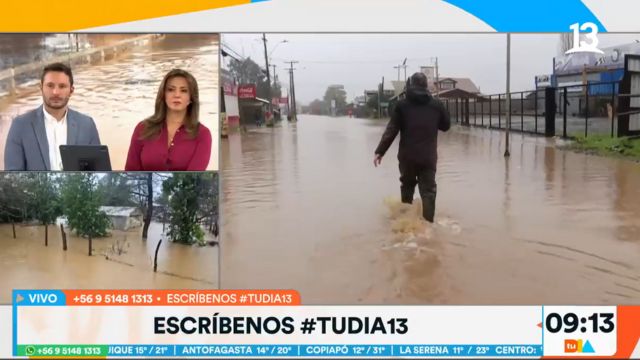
[4,63,100,171]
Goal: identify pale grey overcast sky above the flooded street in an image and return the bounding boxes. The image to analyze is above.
[222,34,640,104]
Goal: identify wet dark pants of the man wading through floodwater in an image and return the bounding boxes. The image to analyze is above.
[400,161,437,222]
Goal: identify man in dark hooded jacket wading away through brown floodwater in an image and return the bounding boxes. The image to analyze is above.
[373,72,451,223]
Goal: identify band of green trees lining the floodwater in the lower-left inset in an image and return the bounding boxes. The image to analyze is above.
[0,172,219,255]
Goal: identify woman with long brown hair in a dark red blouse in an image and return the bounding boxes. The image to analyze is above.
[125,69,211,171]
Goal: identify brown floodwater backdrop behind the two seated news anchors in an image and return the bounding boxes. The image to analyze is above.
[0,34,219,170]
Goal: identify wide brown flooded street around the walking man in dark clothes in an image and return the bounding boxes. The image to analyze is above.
[221,115,640,304]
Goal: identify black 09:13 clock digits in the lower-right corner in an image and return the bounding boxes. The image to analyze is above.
[545,313,616,333]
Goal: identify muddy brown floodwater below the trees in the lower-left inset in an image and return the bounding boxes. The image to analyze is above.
[0,223,218,303]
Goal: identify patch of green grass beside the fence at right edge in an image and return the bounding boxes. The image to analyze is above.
[566,135,640,161]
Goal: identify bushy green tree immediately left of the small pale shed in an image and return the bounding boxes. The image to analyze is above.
[62,173,110,255]
